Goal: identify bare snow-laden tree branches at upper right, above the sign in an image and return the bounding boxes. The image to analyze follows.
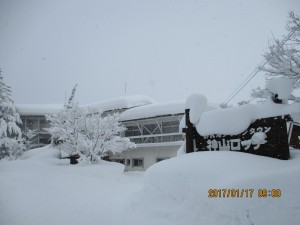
[251,12,300,102]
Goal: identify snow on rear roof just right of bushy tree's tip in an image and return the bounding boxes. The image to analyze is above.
[82,95,155,111]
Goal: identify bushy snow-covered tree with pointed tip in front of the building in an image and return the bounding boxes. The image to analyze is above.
[47,86,135,162]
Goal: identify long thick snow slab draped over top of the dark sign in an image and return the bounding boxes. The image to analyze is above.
[195,102,300,136]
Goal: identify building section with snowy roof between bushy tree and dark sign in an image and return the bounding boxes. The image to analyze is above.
[110,101,184,171]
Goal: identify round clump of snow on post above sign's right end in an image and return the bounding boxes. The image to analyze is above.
[266,77,293,99]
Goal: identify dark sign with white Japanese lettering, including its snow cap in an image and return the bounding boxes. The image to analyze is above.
[183,95,300,159]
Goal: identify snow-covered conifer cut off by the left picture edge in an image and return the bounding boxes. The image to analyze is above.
[0,70,25,160]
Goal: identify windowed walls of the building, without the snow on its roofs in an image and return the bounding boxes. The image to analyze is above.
[21,109,184,171]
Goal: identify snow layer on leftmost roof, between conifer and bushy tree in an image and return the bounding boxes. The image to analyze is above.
[16,104,63,116]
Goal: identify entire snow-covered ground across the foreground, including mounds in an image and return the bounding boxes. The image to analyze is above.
[0,147,300,225]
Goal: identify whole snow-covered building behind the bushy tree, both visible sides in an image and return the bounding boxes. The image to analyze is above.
[16,96,185,171]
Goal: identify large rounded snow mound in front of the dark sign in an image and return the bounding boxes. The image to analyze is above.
[137,151,300,225]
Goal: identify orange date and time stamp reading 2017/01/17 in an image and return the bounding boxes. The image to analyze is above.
[208,188,281,198]
